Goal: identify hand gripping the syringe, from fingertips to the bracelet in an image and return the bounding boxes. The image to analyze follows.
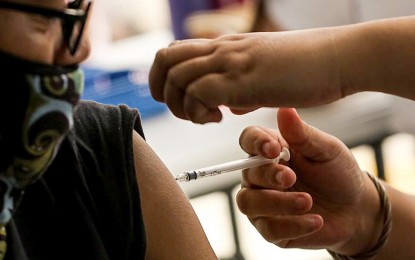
[237,108,382,255]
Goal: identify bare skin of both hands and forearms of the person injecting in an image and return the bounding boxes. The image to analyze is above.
[150,10,415,259]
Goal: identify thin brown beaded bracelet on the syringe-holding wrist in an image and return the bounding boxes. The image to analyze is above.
[327,172,392,260]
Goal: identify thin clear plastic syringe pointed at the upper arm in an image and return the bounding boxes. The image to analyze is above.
[176,147,290,182]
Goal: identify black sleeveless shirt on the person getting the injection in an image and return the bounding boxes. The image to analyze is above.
[6,101,145,260]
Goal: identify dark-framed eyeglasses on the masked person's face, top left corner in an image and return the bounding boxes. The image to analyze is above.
[0,0,92,55]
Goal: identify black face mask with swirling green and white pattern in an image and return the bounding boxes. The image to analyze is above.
[0,52,83,226]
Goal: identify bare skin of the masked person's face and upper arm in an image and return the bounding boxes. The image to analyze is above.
[0,0,217,259]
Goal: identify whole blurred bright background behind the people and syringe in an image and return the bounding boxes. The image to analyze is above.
[83,0,415,260]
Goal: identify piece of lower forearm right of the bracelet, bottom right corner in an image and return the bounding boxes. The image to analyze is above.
[377,185,415,259]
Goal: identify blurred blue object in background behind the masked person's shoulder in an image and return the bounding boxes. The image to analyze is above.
[81,66,167,119]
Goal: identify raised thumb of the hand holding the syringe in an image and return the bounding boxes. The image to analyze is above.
[278,108,341,161]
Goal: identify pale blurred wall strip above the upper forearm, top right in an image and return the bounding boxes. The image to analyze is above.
[265,0,415,30]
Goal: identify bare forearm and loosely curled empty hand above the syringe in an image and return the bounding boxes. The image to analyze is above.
[150,17,415,124]
